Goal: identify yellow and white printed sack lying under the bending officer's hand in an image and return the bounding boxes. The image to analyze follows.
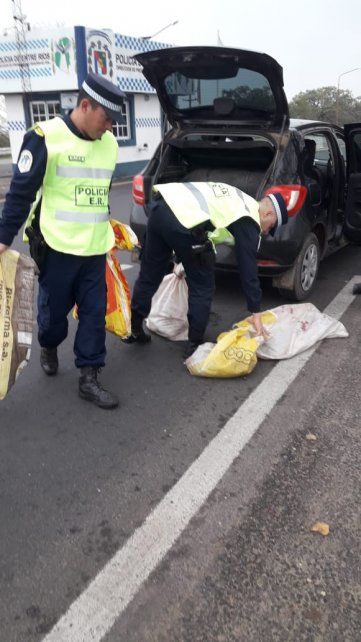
[185,312,276,378]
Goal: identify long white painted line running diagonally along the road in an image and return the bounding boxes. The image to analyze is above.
[43,277,361,642]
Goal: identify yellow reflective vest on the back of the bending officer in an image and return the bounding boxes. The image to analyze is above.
[153,182,260,229]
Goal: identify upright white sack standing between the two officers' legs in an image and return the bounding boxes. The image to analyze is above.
[146,263,188,341]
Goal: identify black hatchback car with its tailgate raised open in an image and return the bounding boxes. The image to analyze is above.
[130,47,361,301]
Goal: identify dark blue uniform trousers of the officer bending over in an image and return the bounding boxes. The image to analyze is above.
[132,199,214,343]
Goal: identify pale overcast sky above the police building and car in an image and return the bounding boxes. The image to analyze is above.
[1,0,361,100]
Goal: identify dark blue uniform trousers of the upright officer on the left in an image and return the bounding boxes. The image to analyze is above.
[38,249,106,368]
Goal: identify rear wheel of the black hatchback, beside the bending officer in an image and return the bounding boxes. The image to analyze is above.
[279,232,320,301]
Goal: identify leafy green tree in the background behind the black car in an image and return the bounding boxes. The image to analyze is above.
[290,87,361,124]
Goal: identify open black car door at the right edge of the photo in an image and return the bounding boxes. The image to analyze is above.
[344,123,361,243]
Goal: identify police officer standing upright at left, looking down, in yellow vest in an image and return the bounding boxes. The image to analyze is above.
[0,73,124,408]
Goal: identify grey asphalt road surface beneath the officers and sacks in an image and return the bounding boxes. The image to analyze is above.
[0,180,361,642]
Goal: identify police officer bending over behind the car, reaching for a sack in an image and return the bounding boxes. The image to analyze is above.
[126,182,288,357]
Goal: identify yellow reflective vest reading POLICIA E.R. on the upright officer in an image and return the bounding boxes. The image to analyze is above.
[25,117,118,256]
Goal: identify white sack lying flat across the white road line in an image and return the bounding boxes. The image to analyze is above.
[257,303,348,359]
